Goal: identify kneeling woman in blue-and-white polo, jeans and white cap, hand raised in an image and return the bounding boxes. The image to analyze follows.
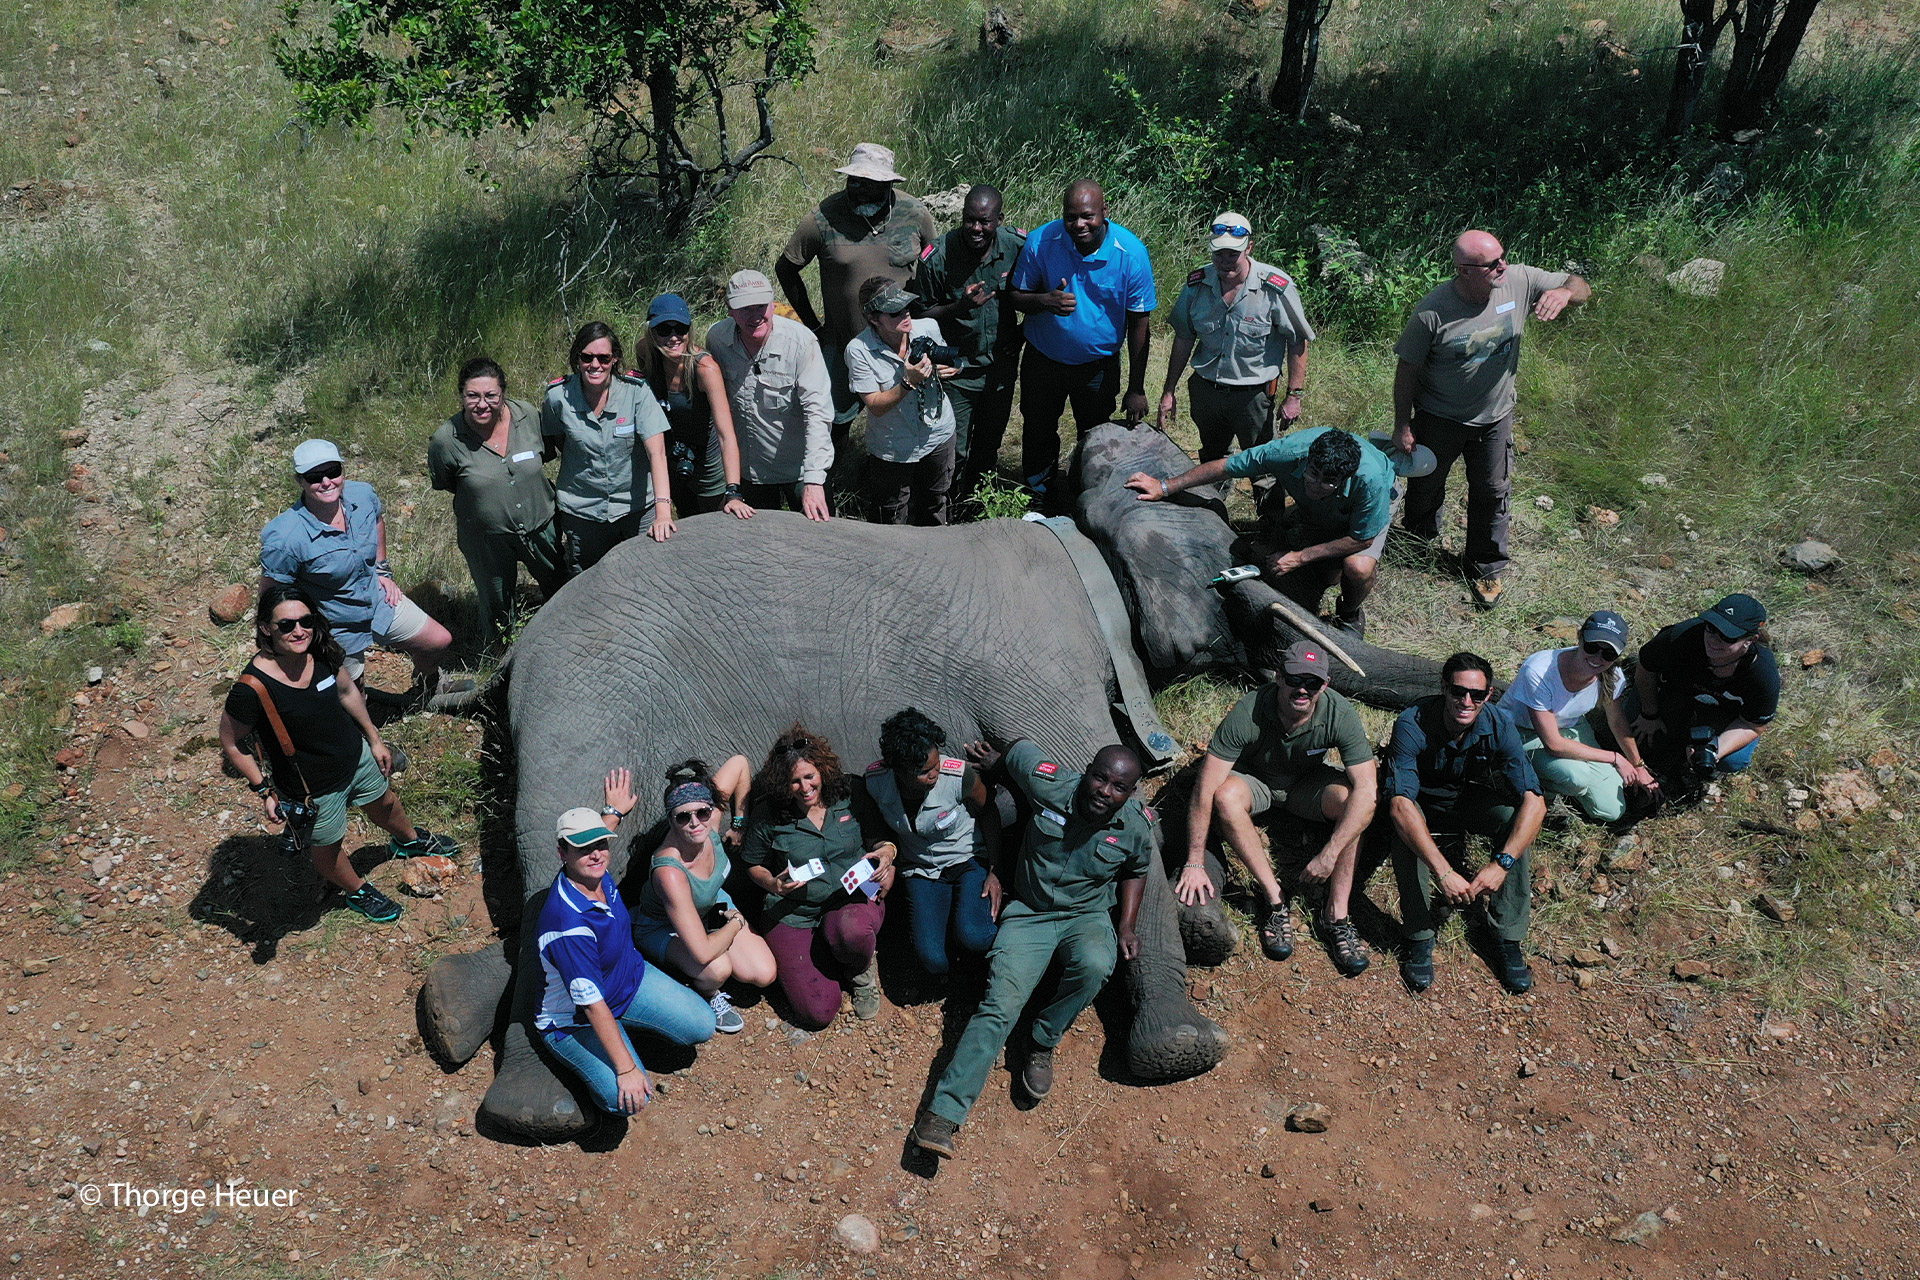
[534,770,714,1115]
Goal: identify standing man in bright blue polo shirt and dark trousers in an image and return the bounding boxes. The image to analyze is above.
[1008,178,1158,493]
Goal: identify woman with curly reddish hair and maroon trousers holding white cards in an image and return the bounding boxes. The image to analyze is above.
[739,725,897,1029]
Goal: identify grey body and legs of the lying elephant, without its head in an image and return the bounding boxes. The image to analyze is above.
[420,512,1231,1142]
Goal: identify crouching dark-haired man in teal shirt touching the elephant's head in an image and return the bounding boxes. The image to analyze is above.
[1127,426,1394,637]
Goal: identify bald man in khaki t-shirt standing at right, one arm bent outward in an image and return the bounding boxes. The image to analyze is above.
[1394,230,1594,608]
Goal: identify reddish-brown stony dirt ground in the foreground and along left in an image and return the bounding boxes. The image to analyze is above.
[0,386,1920,1280]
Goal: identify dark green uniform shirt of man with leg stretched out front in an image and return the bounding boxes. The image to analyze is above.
[1006,741,1154,915]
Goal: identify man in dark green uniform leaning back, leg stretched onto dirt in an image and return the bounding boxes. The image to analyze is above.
[910,741,1154,1155]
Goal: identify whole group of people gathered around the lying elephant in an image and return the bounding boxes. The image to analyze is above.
[221,144,1780,1155]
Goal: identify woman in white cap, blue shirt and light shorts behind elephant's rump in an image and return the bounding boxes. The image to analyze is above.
[259,439,460,700]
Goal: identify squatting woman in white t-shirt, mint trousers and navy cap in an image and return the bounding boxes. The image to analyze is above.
[1500,608,1659,821]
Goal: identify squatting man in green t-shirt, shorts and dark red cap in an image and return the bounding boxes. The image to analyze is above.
[1175,641,1379,977]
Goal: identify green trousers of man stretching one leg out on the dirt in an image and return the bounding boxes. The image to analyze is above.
[927,902,1119,1125]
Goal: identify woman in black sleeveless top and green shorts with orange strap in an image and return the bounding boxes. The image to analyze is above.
[221,583,461,923]
